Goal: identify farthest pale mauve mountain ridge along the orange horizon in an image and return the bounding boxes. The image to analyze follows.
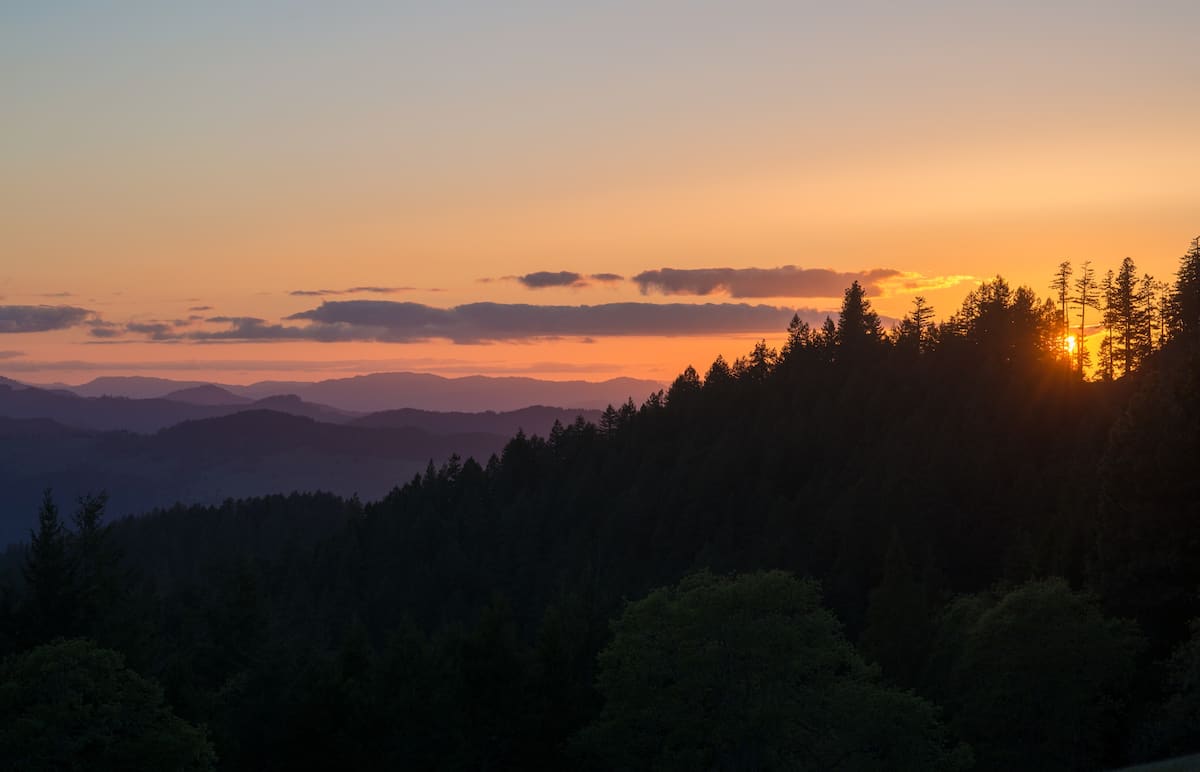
[30,372,662,413]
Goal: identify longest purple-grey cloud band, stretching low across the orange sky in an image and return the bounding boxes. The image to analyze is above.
[124,300,826,343]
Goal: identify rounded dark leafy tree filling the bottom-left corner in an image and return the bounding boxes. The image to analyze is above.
[0,640,215,772]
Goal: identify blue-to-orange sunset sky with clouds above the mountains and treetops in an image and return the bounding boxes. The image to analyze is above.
[0,0,1200,383]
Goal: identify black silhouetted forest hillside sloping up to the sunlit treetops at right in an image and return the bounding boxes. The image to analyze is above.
[0,241,1200,771]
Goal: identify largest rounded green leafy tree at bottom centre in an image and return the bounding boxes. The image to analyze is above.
[580,571,970,770]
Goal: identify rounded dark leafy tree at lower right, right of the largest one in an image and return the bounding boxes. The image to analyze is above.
[935,579,1142,770]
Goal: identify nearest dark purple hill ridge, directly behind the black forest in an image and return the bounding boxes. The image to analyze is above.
[0,410,509,546]
